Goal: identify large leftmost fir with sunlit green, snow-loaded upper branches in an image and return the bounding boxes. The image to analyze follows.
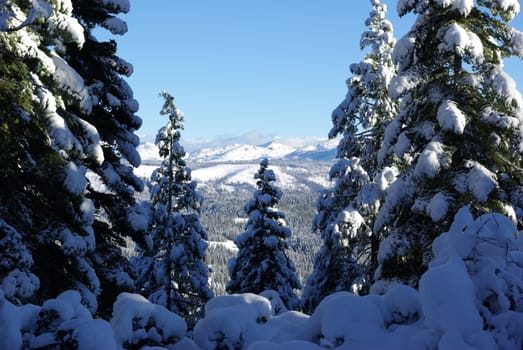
[0,0,106,310]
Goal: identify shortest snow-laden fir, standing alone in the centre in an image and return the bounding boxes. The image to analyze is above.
[226,159,301,310]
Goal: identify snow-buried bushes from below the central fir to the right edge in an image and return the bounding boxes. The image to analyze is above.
[194,211,523,350]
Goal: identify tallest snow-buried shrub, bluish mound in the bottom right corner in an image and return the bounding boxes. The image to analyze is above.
[420,207,523,349]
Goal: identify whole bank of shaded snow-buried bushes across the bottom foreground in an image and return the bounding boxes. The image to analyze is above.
[0,207,523,350]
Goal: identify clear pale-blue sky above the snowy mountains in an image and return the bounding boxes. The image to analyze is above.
[110,0,523,141]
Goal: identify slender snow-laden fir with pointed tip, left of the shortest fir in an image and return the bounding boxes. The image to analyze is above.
[138,92,213,324]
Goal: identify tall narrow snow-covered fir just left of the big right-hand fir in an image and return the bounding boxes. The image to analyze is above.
[302,0,396,313]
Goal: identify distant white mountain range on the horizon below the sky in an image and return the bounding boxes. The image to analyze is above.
[135,140,338,192]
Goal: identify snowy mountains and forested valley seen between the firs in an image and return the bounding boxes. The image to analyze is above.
[135,141,336,295]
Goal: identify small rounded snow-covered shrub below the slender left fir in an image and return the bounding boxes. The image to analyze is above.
[111,293,193,349]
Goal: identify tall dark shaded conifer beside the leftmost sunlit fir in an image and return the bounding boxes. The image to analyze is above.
[61,0,147,316]
